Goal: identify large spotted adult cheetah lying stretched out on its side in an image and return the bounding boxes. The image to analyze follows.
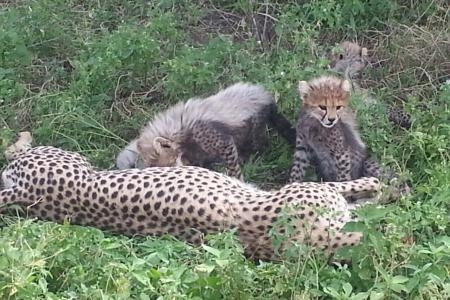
[0,134,380,260]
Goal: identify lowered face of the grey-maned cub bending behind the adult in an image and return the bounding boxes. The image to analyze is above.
[137,137,186,167]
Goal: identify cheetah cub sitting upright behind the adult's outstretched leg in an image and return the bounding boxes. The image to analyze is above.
[290,76,381,188]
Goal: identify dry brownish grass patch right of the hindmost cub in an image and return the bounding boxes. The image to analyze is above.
[366,24,450,100]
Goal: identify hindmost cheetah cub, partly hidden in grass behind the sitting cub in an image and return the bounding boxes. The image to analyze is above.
[330,41,411,129]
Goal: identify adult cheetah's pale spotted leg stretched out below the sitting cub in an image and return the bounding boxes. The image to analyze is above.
[324,177,382,196]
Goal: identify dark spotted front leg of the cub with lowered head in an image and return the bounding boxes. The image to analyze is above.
[192,122,244,180]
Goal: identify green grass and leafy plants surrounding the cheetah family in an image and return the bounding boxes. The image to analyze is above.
[0,0,450,300]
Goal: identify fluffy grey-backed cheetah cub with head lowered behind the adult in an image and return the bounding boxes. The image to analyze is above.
[117,83,295,179]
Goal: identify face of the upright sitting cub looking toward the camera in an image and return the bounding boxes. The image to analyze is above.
[298,76,351,128]
